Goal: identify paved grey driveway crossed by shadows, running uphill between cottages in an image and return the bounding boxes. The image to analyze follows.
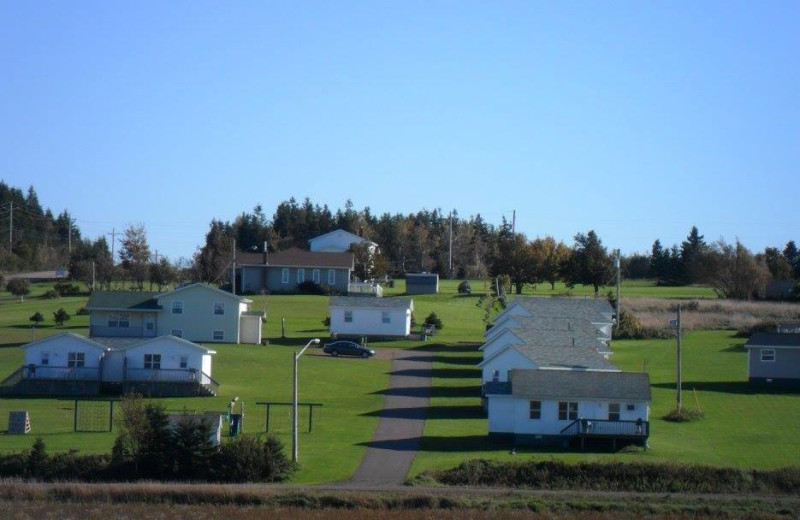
[350,350,433,485]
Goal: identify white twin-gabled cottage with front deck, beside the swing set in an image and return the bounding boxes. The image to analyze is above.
[0,333,219,397]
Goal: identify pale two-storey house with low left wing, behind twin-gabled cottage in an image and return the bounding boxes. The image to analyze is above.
[86,283,265,344]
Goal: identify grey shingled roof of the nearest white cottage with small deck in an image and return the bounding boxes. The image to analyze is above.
[509,369,650,401]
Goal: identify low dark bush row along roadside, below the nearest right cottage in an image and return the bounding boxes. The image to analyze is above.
[418,459,800,495]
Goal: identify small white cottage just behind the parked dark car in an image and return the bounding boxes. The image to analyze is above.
[330,296,414,338]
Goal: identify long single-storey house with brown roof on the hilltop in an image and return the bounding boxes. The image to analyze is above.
[237,248,355,294]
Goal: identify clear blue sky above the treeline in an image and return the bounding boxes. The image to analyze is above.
[0,0,800,259]
